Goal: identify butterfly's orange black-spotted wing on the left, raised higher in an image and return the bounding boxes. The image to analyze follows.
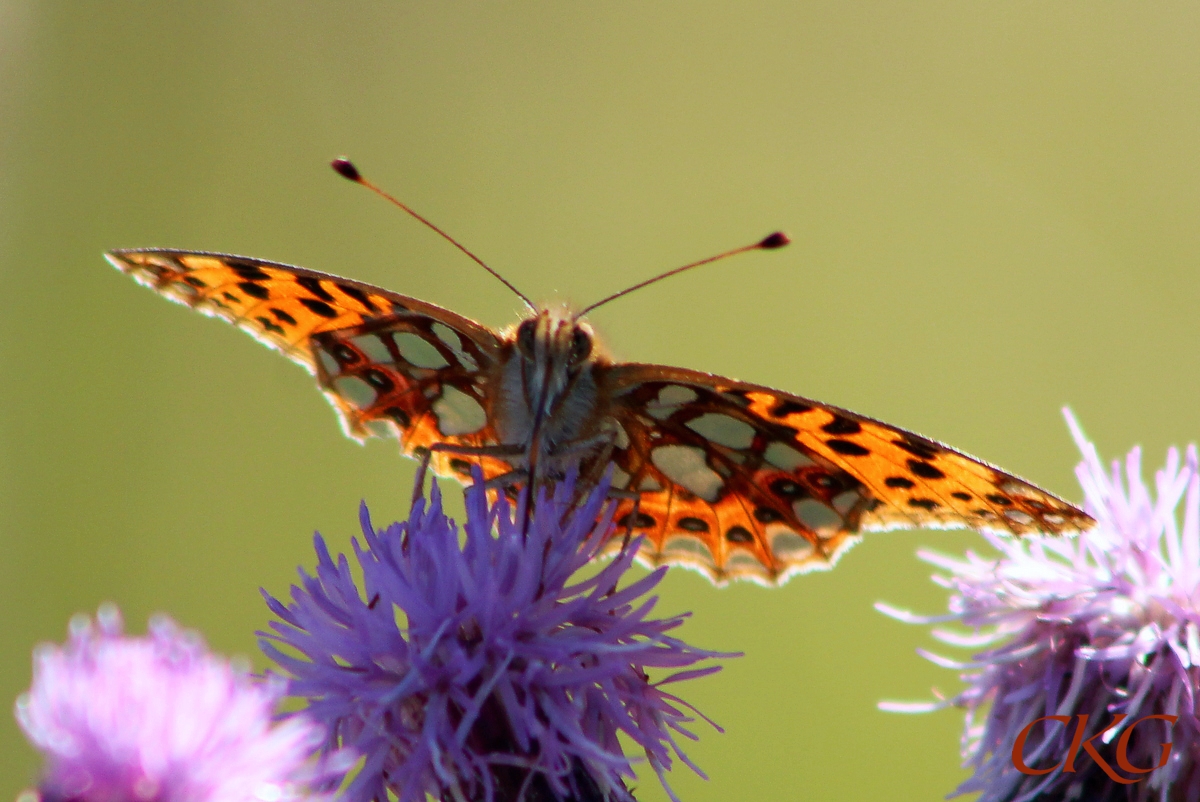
[107,249,508,478]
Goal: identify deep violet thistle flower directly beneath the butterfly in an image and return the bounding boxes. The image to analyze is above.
[263,477,733,802]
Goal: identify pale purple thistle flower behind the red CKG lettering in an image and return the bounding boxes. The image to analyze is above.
[876,411,1200,802]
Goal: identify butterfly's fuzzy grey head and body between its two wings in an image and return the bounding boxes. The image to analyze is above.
[492,309,606,473]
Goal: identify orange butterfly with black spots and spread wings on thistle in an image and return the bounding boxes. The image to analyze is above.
[107,241,1094,585]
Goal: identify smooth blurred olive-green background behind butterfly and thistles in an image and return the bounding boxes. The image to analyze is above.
[0,1,1200,802]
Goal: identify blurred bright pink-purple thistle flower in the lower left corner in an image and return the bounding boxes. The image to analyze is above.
[17,605,349,802]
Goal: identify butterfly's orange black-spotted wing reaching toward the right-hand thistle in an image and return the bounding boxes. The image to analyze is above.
[607,364,1094,585]
